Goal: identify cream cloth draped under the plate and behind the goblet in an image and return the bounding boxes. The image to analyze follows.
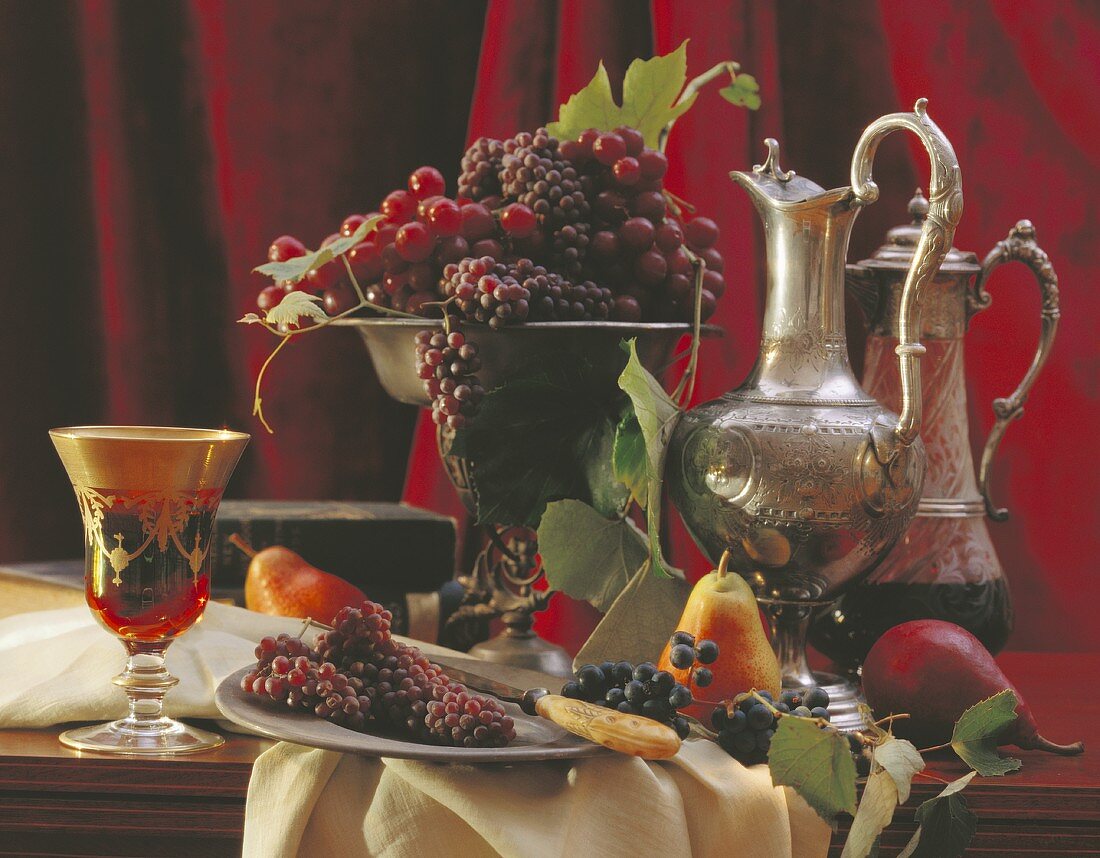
[0,579,829,858]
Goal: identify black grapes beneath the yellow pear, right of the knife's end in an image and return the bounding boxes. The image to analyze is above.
[711,688,829,766]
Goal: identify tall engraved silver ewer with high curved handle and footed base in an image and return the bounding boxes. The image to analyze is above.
[667,99,963,727]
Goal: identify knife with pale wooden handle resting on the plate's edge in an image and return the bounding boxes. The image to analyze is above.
[432,659,680,760]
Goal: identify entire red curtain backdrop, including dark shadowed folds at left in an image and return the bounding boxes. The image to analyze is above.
[0,0,1100,649]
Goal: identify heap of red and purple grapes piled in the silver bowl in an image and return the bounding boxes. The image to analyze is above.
[251,127,725,328]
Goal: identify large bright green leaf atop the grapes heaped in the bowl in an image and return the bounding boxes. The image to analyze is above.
[547,40,697,147]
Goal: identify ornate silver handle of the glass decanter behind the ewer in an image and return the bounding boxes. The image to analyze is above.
[967,220,1062,521]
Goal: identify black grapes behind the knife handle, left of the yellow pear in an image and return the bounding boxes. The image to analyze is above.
[561,661,708,739]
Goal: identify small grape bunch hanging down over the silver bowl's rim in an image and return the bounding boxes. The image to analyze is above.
[416,330,485,429]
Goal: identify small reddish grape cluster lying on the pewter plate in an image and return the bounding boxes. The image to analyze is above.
[241,602,516,748]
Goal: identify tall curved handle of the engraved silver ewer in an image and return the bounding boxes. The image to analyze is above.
[851,98,963,459]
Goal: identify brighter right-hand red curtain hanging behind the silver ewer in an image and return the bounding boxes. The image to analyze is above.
[405,0,1100,649]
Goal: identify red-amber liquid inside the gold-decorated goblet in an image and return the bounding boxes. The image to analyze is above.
[84,508,216,641]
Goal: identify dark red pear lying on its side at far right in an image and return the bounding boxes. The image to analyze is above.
[864,619,1085,755]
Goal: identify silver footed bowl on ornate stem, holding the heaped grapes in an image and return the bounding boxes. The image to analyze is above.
[337,319,716,677]
